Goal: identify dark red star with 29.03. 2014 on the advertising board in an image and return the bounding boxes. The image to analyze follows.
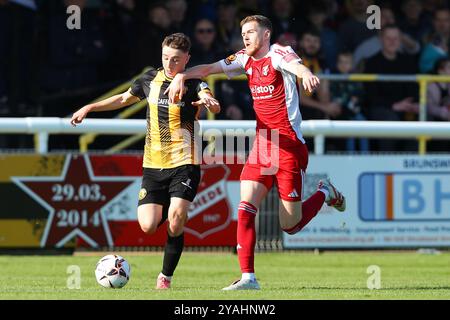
[11,155,136,248]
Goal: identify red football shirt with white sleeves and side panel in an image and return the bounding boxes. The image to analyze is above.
[220,44,305,147]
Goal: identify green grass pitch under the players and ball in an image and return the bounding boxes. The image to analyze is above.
[0,251,450,300]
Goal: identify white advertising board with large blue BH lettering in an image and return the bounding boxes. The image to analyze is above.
[283,155,450,248]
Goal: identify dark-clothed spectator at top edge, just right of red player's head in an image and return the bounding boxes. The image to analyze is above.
[270,0,305,39]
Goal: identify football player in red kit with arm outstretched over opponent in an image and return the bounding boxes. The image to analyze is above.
[167,15,345,290]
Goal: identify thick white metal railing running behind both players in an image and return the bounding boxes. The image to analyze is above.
[0,118,450,154]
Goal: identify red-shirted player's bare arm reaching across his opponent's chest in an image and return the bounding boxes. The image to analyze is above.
[164,62,223,103]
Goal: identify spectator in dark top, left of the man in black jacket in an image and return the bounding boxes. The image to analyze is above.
[330,51,369,152]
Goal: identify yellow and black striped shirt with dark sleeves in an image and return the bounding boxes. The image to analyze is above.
[131,68,210,168]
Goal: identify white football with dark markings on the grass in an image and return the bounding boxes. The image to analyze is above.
[95,254,131,289]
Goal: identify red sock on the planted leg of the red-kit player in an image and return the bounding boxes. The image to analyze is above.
[237,201,258,273]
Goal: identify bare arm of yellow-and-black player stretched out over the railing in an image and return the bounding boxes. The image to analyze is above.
[70,90,139,127]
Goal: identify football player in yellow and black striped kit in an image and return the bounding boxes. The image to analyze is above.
[71,33,220,289]
